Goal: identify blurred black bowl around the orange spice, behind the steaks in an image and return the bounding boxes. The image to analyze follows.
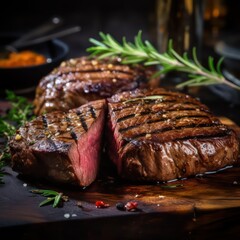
[0,36,69,94]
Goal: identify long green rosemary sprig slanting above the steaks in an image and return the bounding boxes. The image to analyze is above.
[87,31,240,90]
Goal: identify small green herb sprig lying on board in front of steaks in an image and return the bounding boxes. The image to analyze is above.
[30,189,68,208]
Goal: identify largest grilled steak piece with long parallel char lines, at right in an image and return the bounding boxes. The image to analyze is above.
[107,88,239,181]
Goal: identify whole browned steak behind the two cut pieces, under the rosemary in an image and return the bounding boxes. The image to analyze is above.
[34,57,157,115]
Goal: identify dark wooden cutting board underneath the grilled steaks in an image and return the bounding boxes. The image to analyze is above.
[0,118,240,240]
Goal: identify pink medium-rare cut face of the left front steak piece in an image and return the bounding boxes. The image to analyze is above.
[69,112,104,186]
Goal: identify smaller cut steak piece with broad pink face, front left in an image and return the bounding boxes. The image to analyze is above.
[10,100,106,186]
